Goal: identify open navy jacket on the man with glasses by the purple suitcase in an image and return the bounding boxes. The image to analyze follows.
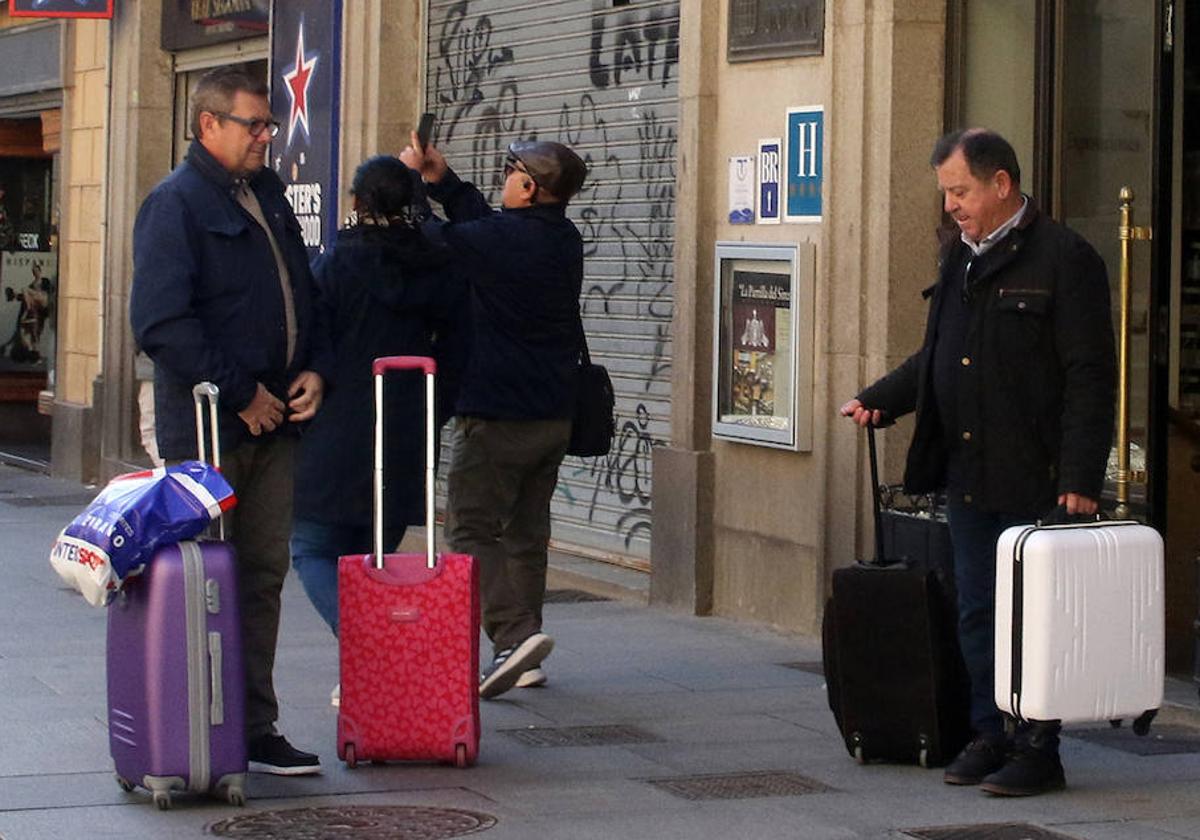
[130,142,328,460]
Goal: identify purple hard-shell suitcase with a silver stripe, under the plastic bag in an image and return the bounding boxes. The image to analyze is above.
[107,383,246,810]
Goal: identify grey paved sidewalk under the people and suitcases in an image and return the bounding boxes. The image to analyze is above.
[0,466,1200,840]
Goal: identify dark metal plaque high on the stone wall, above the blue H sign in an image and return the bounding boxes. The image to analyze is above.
[726,0,824,61]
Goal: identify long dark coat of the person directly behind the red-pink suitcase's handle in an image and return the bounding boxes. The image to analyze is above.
[294,224,468,527]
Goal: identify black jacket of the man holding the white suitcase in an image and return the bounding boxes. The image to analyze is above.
[858,202,1116,517]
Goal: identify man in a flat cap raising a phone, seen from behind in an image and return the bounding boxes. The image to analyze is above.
[400,132,587,698]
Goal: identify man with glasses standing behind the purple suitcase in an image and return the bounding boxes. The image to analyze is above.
[130,67,328,775]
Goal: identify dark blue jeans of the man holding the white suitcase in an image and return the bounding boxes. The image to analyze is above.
[946,498,1030,734]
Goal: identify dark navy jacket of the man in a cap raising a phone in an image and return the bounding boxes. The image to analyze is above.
[424,172,583,420]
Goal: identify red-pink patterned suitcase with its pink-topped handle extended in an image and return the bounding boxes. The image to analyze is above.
[337,356,479,767]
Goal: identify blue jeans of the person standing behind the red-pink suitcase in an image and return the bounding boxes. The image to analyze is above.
[292,518,407,636]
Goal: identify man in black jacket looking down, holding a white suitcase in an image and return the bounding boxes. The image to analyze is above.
[841,128,1116,796]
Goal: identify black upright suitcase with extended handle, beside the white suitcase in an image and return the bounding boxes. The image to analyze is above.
[822,427,970,767]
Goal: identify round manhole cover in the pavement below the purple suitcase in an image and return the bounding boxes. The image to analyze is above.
[209,805,496,840]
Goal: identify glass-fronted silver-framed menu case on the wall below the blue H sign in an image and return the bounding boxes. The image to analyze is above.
[713,242,814,450]
